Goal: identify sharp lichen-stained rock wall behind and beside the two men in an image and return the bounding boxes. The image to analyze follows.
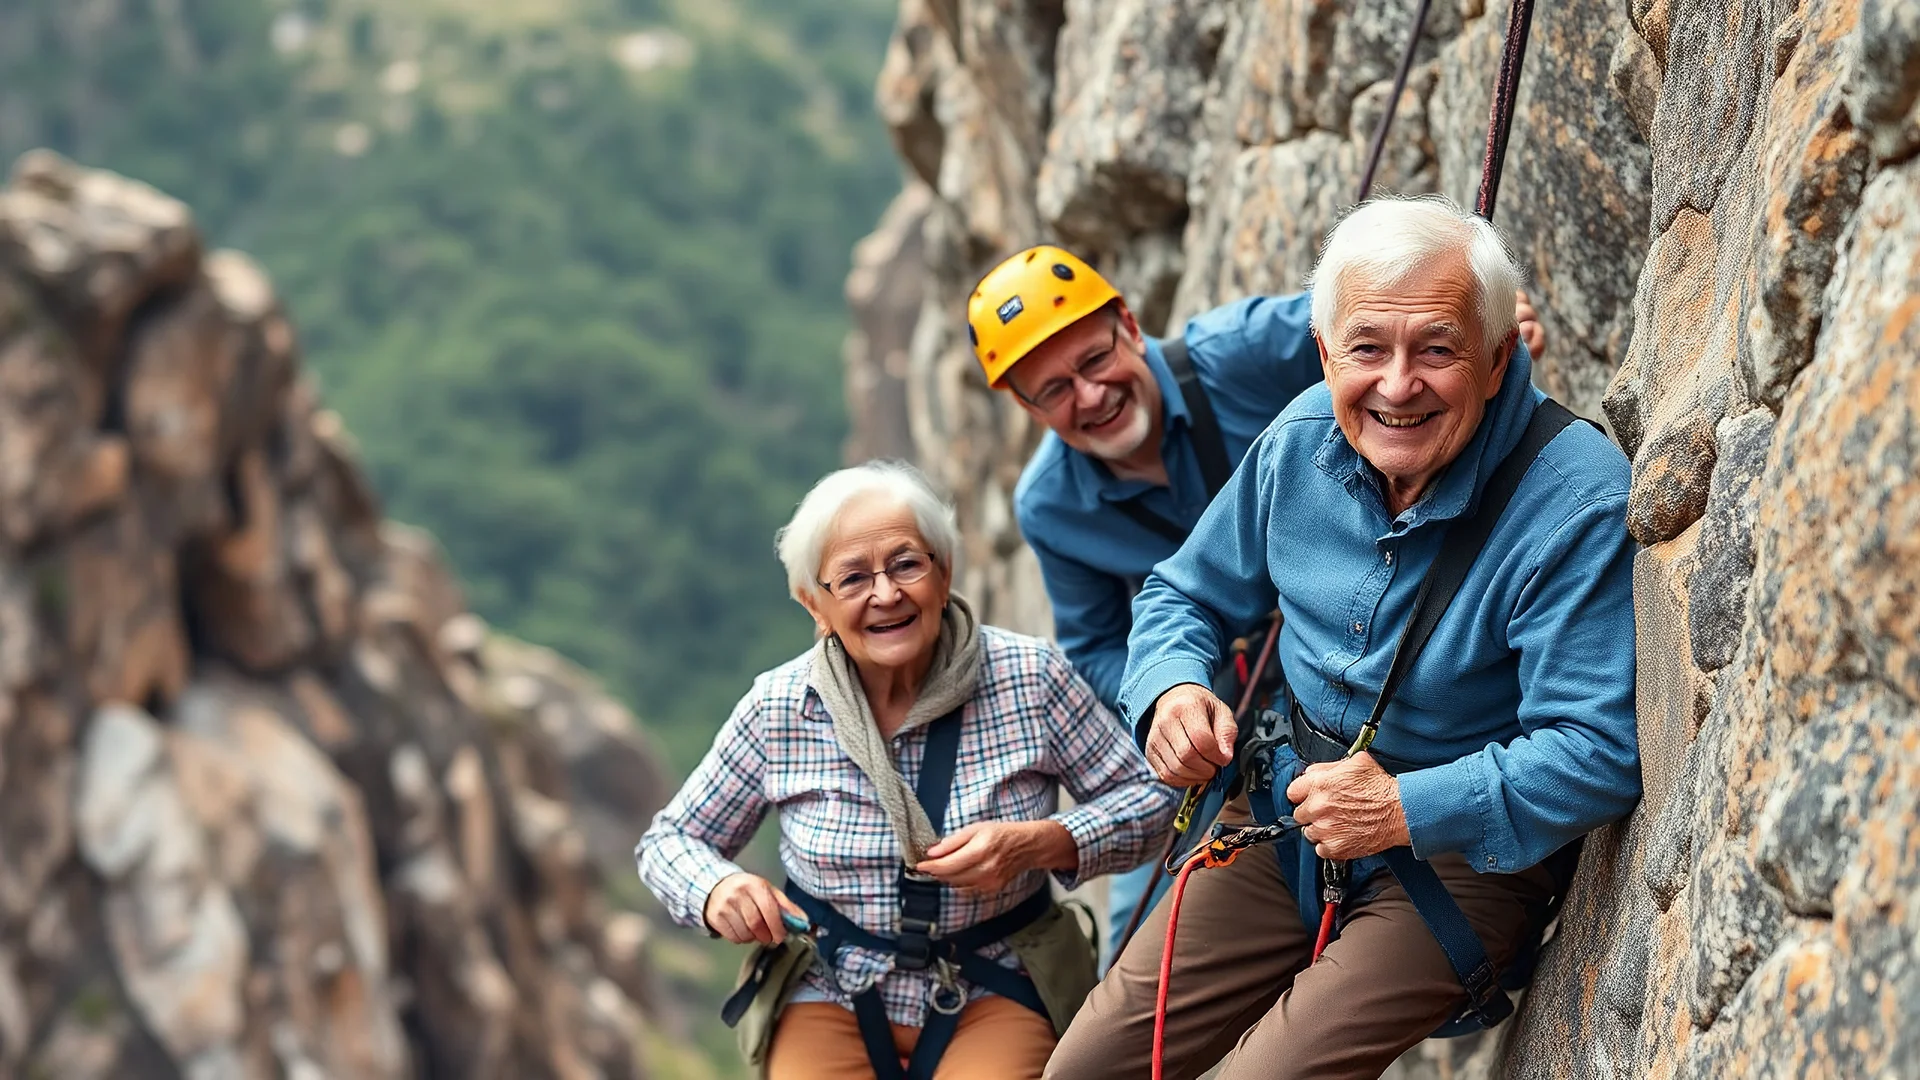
[854,0,1920,1078]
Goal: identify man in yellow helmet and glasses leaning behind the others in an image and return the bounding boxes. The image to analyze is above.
[968,244,1546,951]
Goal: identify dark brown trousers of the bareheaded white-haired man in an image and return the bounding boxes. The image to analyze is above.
[1046,799,1553,1080]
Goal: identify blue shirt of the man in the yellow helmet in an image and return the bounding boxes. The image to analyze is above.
[1014,294,1321,705]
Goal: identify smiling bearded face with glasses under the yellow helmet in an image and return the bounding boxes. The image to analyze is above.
[1006,306,1160,461]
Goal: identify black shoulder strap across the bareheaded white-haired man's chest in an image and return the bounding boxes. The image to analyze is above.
[1356,398,1576,749]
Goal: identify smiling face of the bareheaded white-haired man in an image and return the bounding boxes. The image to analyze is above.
[1317,256,1513,515]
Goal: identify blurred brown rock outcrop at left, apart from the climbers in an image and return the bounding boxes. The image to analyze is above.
[0,154,664,1080]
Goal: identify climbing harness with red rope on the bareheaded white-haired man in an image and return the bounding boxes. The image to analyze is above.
[1154,398,1578,1076]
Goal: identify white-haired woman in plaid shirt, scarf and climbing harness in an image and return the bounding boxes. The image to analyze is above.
[637,463,1175,1080]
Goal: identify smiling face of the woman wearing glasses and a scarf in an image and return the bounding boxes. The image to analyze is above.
[801,494,950,673]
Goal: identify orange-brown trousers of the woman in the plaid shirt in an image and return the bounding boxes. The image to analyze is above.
[766,997,1054,1080]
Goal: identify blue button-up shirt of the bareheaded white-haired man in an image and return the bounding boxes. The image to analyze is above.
[1121,346,1640,872]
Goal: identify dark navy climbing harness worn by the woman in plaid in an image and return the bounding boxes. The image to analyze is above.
[720,709,1054,1080]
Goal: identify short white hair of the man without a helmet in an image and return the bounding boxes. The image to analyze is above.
[1308,194,1521,350]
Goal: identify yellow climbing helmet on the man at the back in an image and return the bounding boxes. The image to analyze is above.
[966,244,1119,390]
